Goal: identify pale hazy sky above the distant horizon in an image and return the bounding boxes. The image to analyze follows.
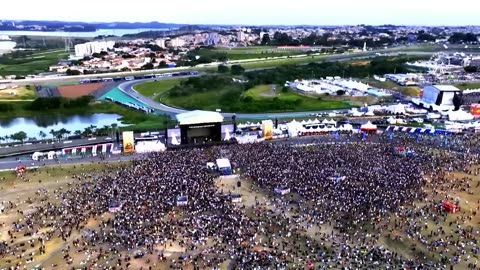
[0,0,480,25]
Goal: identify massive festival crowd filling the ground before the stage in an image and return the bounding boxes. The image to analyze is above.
[0,135,480,269]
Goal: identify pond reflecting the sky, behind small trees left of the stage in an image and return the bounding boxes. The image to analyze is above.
[0,113,122,139]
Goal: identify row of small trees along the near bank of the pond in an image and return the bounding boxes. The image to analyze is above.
[0,124,118,146]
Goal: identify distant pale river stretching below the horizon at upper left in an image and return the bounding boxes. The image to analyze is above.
[0,28,170,38]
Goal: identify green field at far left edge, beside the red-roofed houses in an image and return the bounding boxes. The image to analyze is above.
[0,50,68,76]
